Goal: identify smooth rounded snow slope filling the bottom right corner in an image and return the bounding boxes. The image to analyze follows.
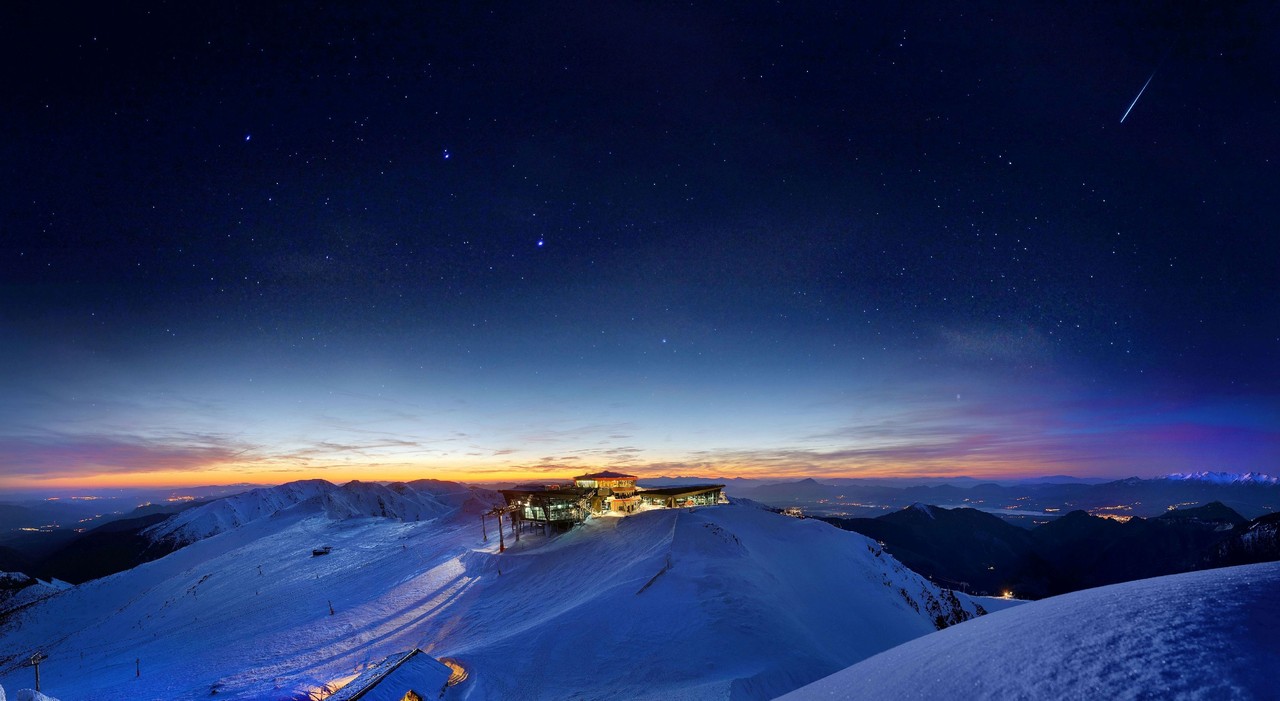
[783,563,1280,701]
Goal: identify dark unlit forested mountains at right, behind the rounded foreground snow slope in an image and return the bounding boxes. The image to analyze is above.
[824,501,1280,599]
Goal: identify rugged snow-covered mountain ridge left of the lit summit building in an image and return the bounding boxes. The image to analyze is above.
[145,480,493,546]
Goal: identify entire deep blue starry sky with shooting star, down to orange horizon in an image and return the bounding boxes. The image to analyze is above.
[0,1,1280,487]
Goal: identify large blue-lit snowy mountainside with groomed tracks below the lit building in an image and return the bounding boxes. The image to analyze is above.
[0,484,977,701]
